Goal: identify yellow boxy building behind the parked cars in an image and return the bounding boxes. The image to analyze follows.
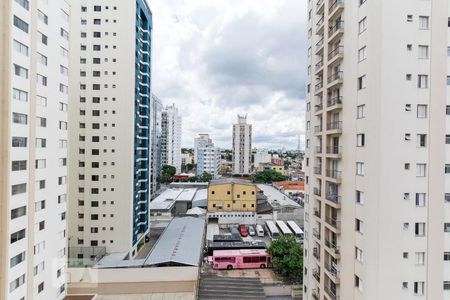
[208,179,256,212]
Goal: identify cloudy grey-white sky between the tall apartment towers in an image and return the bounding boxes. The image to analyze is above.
[148,0,306,149]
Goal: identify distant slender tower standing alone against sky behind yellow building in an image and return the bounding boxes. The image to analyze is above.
[233,115,252,175]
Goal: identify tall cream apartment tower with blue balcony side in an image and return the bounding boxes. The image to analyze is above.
[68,0,152,258]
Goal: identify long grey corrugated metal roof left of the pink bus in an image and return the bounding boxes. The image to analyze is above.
[144,217,205,266]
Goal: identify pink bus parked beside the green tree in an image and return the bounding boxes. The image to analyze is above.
[208,249,272,270]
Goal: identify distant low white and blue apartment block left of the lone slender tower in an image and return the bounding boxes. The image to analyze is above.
[194,134,221,178]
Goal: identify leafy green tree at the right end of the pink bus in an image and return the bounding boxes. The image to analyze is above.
[267,236,303,283]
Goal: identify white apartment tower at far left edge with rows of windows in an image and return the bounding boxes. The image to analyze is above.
[0,0,70,300]
